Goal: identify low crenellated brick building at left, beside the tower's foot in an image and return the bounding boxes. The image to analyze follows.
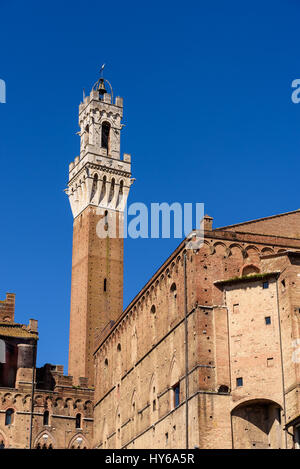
[0,294,94,449]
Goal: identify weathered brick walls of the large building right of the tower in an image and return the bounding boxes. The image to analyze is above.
[94,221,300,448]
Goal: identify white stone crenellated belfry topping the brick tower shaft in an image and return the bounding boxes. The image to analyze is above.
[66,79,133,218]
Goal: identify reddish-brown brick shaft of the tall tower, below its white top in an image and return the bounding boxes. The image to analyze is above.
[69,207,123,385]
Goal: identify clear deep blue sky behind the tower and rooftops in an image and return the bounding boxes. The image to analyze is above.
[0,0,300,365]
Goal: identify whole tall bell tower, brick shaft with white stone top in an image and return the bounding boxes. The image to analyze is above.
[66,72,132,386]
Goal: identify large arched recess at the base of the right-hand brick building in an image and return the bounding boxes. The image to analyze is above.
[231,399,283,449]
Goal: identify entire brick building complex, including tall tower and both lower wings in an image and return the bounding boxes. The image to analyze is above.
[0,78,300,449]
